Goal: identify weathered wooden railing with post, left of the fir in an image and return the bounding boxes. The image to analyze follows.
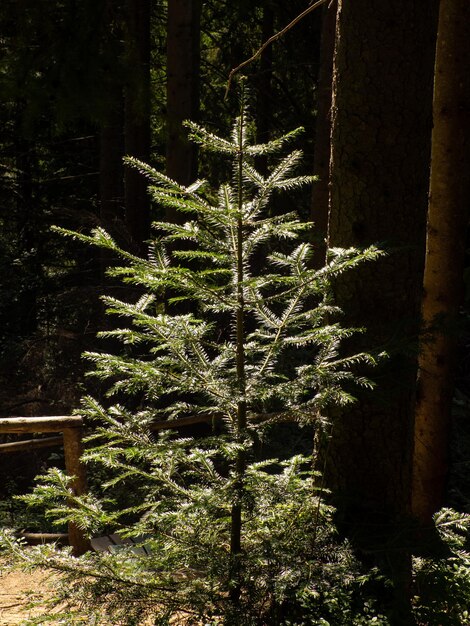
[0,415,90,555]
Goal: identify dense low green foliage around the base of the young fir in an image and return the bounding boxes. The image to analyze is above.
[0,454,387,626]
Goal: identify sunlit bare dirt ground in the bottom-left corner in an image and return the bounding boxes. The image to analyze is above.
[0,563,58,626]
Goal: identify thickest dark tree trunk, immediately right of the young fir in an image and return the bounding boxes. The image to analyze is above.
[326,0,438,626]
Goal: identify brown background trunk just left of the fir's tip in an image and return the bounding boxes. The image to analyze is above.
[166,0,201,210]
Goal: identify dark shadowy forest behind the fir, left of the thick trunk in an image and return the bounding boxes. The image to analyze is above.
[0,1,322,495]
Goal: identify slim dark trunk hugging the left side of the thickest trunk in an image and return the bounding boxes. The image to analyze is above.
[311,4,336,267]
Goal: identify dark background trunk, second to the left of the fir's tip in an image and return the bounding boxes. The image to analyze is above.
[124,0,150,254]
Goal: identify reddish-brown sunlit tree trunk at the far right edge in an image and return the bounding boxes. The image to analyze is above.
[412,0,470,524]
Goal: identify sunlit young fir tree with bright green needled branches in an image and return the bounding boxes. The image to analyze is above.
[0,95,386,625]
